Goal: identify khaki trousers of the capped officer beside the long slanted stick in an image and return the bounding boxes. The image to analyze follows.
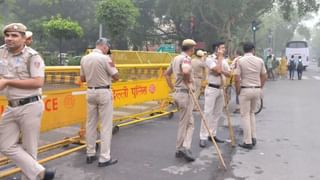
[173,93,194,150]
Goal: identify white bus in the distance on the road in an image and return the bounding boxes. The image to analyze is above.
[286,41,309,69]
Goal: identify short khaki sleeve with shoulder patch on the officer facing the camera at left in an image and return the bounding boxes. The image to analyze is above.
[29,55,45,77]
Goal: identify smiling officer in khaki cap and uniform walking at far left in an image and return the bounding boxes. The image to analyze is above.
[0,23,55,180]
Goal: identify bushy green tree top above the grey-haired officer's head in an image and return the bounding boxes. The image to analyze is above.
[97,0,139,49]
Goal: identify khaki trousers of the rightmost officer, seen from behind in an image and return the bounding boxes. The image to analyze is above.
[240,88,261,144]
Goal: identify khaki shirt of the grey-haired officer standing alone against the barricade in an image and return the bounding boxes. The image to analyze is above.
[80,49,118,87]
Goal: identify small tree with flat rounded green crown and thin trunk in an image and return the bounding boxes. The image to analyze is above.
[43,15,83,64]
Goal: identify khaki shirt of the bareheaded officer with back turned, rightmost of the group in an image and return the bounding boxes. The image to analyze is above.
[236,53,267,86]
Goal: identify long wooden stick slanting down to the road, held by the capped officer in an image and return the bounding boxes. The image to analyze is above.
[189,88,227,169]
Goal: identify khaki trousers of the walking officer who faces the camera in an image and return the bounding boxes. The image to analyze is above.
[0,101,45,180]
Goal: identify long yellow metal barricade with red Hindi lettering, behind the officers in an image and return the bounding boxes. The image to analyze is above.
[0,64,176,179]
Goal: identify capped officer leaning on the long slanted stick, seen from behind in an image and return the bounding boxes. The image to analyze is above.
[165,39,196,162]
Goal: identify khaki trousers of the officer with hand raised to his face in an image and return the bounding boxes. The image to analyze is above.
[200,87,224,140]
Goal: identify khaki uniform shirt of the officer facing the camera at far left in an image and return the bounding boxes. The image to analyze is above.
[0,45,45,100]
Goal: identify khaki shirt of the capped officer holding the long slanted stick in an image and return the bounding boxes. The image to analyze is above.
[168,52,193,89]
